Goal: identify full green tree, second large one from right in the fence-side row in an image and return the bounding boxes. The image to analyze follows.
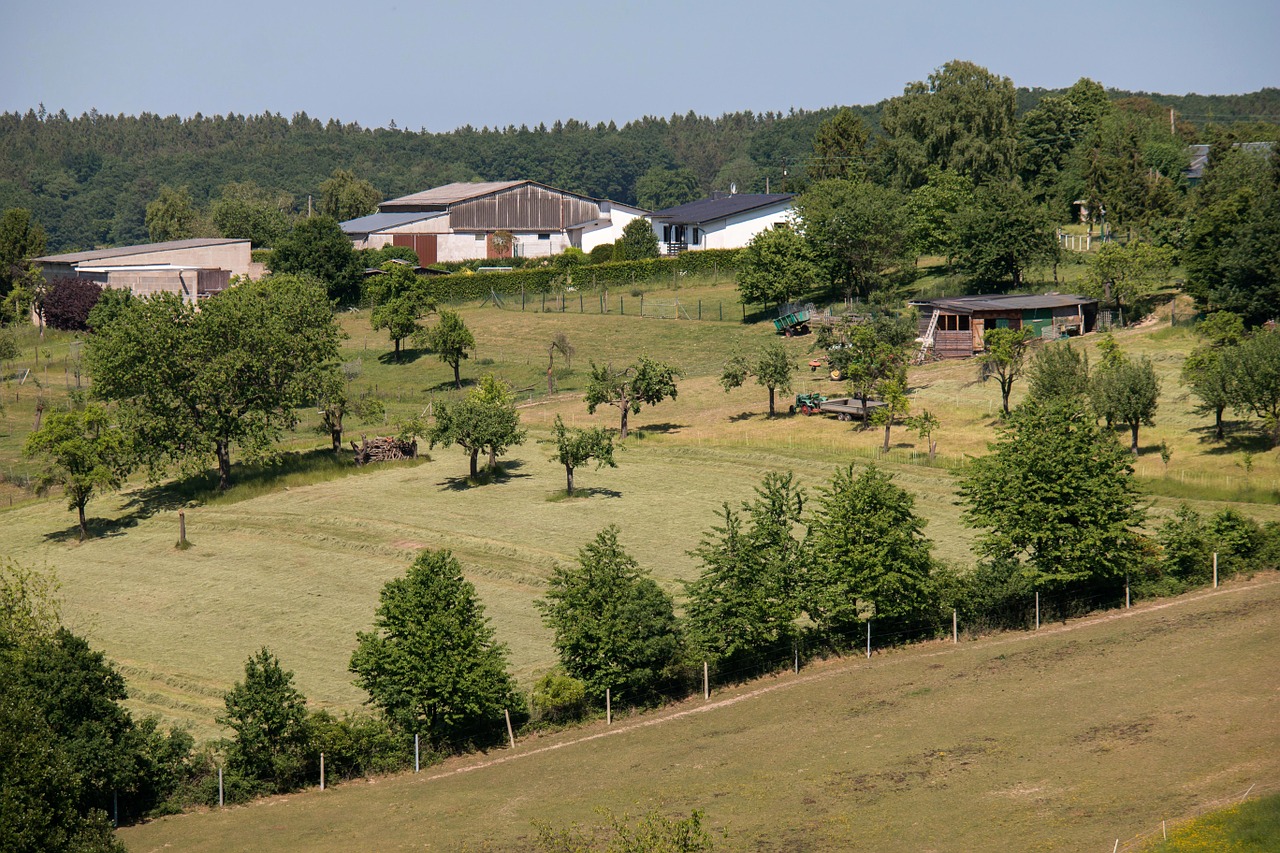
[804,465,933,635]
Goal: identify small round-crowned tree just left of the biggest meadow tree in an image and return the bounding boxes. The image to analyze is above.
[26,405,134,542]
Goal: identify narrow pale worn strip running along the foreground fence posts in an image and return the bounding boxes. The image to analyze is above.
[410,578,1280,783]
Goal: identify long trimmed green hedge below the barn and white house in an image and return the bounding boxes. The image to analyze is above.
[422,248,740,302]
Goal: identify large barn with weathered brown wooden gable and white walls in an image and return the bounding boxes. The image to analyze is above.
[342,181,645,265]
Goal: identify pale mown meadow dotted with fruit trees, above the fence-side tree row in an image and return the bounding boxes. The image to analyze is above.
[0,284,1280,738]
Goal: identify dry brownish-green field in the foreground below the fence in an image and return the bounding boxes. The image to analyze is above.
[120,574,1280,853]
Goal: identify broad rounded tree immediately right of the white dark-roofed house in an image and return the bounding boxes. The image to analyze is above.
[795,181,914,298]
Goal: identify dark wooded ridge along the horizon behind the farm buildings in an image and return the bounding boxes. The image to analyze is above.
[0,68,1280,252]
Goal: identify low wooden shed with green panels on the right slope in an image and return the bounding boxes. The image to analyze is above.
[911,293,1098,359]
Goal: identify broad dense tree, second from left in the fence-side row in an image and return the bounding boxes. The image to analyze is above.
[351,551,524,748]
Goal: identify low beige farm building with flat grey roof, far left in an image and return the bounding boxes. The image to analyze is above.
[35,237,264,302]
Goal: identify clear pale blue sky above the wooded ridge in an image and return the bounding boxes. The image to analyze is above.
[0,0,1280,131]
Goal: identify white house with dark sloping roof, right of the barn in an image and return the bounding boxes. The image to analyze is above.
[649,192,795,255]
